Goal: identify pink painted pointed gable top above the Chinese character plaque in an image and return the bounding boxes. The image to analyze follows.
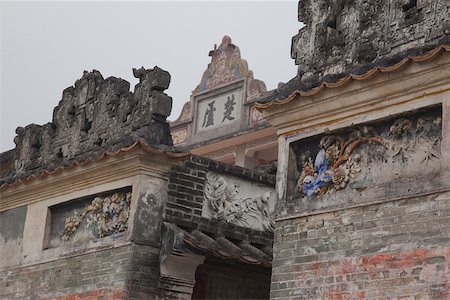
[193,35,266,100]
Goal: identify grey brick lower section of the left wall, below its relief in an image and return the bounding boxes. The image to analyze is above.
[0,245,159,299]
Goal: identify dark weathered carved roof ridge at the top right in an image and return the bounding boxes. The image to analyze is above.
[291,0,450,80]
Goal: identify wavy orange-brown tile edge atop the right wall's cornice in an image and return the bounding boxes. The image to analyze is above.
[256,45,450,109]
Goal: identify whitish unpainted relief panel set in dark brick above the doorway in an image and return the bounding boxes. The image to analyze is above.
[202,172,274,231]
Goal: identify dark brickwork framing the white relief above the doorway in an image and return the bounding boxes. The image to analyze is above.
[164,155,275,244]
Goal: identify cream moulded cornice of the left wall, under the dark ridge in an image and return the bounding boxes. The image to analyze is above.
[0,148,184,211]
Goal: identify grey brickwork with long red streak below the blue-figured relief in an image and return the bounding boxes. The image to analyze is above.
[271,192,450,299]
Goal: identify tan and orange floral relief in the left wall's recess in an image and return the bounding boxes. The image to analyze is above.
[61,192,131,241]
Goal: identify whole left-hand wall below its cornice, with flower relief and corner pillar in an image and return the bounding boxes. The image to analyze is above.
[0,176,171,299]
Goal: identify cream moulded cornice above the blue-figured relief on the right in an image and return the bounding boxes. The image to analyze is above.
[259,51,450,135]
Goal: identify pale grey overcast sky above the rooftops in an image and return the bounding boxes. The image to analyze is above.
[0,1,301,152]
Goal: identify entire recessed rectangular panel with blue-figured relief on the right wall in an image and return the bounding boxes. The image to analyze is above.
[293,109,442,197]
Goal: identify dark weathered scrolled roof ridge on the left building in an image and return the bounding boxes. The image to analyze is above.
[9,67,172,177]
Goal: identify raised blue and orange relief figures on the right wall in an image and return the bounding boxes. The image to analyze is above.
[296,114,442,197]
